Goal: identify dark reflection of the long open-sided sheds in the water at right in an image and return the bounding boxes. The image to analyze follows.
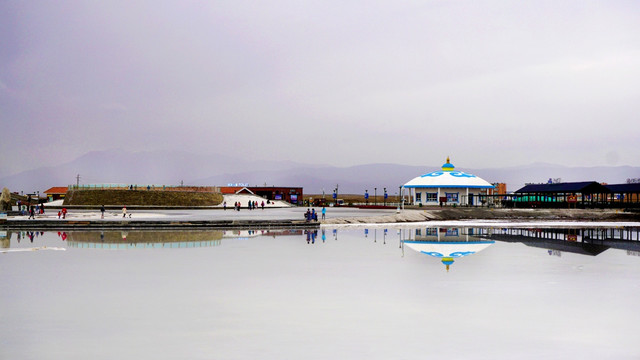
[489,228,640,256]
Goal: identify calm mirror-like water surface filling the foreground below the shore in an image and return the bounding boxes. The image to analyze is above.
[0,227,640,359]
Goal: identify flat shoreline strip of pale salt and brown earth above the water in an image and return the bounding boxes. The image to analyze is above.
[5,207,640,230]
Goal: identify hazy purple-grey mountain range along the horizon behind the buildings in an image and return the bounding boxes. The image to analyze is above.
[0,150,640,195]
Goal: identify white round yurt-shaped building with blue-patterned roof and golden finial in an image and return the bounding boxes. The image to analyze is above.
[403,158,493,205]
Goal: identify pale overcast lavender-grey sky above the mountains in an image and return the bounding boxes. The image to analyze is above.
[0,0,640,175]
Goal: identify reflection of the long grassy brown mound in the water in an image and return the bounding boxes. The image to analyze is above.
[64,230,222,250]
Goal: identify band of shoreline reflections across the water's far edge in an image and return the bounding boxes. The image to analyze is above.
[0,226,640,260]
